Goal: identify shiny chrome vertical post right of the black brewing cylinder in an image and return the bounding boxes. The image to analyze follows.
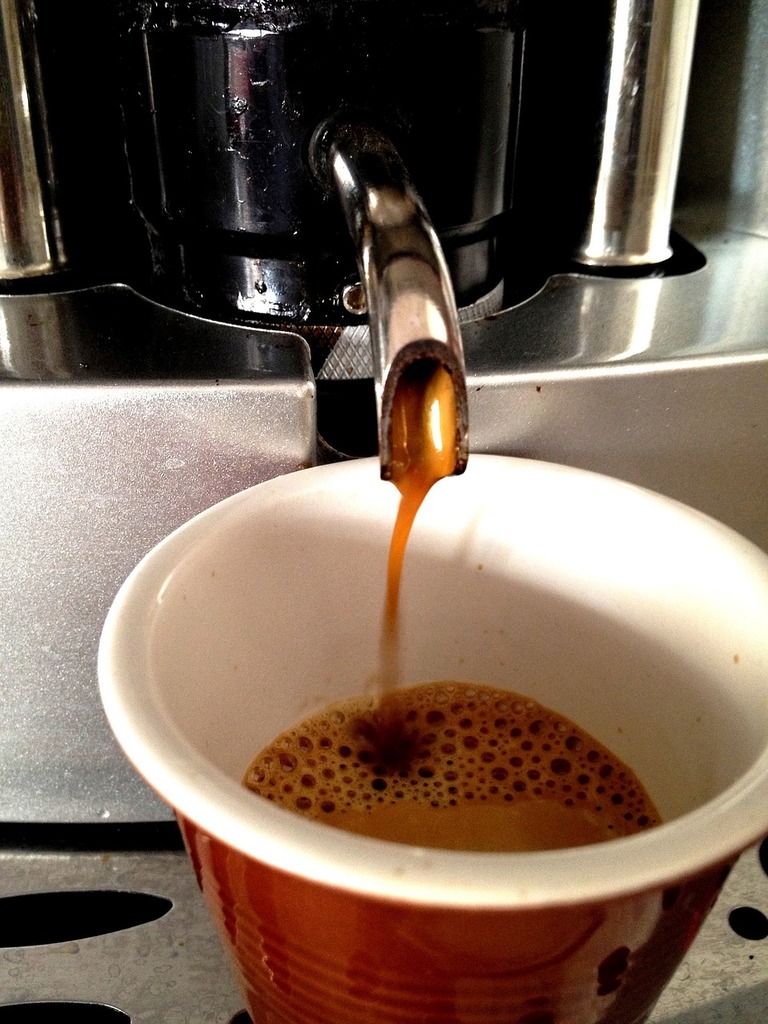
[575,0,698,266]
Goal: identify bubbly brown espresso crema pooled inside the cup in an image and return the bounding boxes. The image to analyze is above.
[244,682,660,852]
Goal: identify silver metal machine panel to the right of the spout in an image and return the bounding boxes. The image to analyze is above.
[464,216,768,550]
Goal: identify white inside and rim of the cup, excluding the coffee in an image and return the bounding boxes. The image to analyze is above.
[99,456,768,902]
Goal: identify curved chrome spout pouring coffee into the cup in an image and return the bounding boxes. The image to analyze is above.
[311,122,469,479]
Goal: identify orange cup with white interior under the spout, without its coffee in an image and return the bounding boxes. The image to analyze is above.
[98,455,768,1024]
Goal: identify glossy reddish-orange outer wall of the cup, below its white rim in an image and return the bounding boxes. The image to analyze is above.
[179,818,730,1024]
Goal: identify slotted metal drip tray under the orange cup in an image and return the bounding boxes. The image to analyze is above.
[0,849,768,1024]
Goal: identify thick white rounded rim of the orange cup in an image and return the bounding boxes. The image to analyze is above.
[98,455,768,909]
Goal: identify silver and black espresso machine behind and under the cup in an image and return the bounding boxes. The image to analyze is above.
[0,0,768,1024]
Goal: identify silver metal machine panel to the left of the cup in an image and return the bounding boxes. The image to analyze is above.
[0,290,315,821]
